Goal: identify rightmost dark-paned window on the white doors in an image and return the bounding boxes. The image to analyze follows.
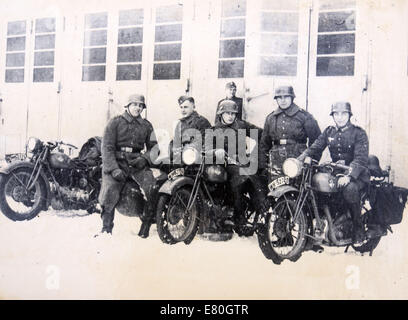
[316,0,356,76]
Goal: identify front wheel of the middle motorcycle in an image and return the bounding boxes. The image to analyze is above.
[156,187,199,244]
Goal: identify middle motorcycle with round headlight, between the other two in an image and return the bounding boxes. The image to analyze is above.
[156,147,258,244]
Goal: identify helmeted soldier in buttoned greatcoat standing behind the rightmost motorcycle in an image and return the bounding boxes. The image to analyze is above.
[260,86,321,168]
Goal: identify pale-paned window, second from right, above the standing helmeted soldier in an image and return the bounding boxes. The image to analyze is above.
[259,0,299,77]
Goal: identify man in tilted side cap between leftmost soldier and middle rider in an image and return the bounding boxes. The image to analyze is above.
[172,96,211,158]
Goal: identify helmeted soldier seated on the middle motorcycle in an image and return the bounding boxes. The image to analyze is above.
[205,100,266,230]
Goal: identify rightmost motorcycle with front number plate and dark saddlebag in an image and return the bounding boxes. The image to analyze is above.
[258,156,408,264]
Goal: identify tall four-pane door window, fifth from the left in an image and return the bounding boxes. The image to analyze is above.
[153,5,183,80]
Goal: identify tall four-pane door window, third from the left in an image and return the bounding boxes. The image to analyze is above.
[82,12,108,81]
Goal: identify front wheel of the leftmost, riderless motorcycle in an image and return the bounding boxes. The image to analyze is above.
[0,168,47,221]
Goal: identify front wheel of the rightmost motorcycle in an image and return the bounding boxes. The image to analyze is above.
[258,199,308,264]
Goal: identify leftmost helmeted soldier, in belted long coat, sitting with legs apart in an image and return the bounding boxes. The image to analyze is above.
[99,94,157,238]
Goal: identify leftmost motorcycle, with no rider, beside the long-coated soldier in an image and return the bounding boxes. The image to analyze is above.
[0,137,102,221]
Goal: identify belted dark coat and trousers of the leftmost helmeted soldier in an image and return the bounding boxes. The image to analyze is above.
[99,111,158,232]
